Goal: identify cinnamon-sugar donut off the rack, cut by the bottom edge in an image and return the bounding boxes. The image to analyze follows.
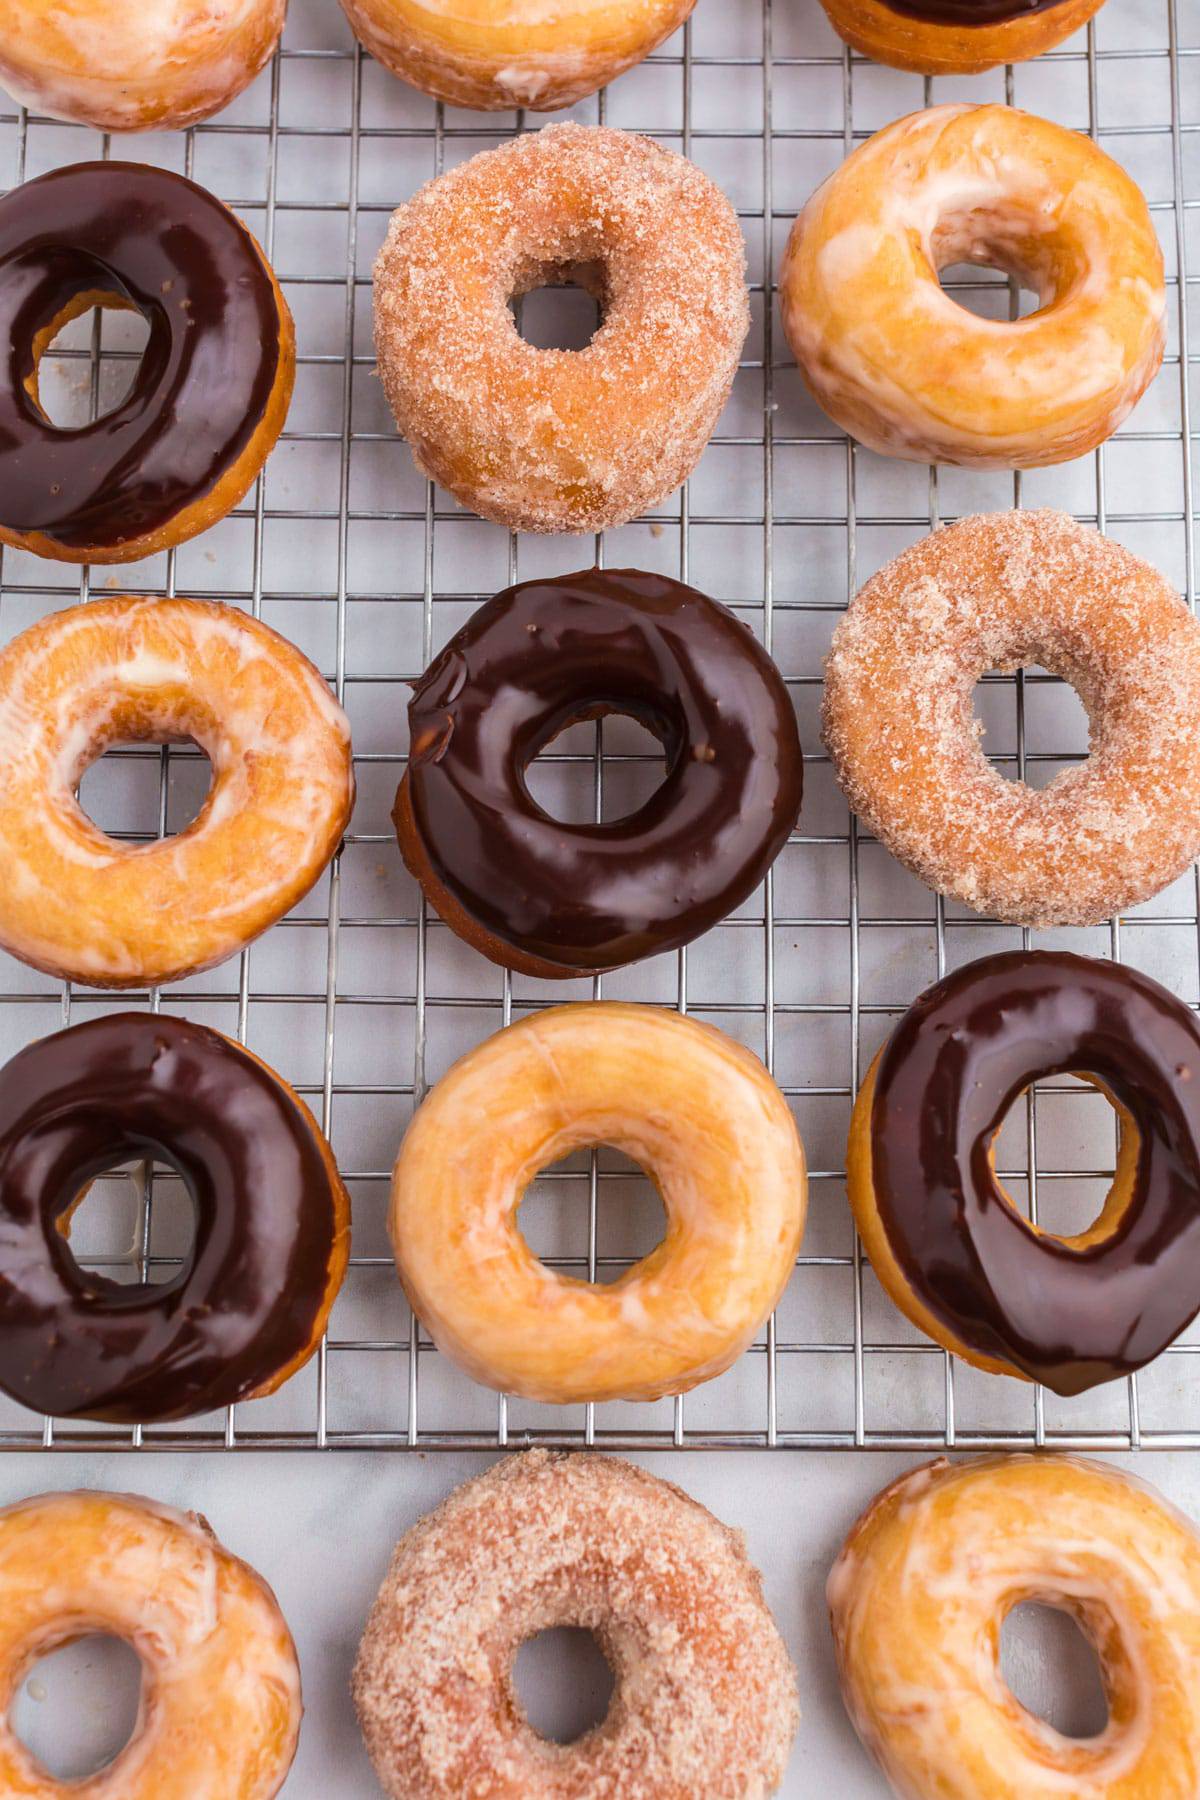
[353,1451,799,1800]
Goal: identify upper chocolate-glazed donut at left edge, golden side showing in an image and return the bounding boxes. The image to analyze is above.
[0,168,295,563]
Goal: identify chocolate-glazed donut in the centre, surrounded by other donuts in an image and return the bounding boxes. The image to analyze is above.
[394,569,802,977]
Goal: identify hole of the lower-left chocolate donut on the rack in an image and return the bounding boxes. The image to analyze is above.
[58,1159,196,1287]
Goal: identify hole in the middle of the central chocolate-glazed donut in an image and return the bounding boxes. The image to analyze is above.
[524,713,667,824]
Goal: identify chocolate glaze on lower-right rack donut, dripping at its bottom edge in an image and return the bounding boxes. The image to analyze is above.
[871,950,1200,1393]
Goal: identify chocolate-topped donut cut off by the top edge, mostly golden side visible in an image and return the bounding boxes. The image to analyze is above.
[820,0,1105,76]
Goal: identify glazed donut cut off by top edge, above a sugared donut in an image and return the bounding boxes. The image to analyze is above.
[342,0,696,112]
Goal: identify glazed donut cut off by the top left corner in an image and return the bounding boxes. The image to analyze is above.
[0,0,288,131]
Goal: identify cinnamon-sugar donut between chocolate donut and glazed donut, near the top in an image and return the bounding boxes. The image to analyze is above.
[374,124,750,531]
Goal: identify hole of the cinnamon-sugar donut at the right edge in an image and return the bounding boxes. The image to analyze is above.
[973,662,1090,790]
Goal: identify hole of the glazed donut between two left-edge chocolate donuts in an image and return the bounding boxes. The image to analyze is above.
[76,740,212,844]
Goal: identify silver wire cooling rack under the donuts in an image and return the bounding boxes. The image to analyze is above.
[0,0,1200,1451]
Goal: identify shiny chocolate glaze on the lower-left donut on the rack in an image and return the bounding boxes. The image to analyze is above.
[0,1013,338,1424]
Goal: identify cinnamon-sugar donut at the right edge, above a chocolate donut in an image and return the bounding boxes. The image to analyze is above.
[822,513,1200,925]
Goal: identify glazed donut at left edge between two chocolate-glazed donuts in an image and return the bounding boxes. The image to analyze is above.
[0,596,354,988]
